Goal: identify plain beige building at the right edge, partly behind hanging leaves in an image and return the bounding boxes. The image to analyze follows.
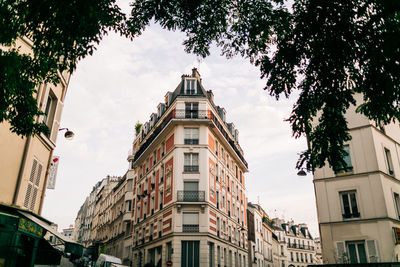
[314,95,400,263]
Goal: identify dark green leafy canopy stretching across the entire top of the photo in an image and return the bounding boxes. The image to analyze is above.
[0,0,400,170]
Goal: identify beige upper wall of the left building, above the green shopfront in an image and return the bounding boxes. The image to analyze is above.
[0,37,70,214]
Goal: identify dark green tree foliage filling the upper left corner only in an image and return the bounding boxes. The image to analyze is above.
[0,0,127,135]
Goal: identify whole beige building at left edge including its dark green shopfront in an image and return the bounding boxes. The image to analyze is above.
[0,36,74,266]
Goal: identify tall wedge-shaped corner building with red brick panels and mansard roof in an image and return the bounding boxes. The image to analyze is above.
[127,69,248,267]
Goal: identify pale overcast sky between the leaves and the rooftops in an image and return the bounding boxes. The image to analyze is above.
[42,9,319,236]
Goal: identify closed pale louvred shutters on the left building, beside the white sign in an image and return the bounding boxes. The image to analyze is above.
[24,159,43,211]
